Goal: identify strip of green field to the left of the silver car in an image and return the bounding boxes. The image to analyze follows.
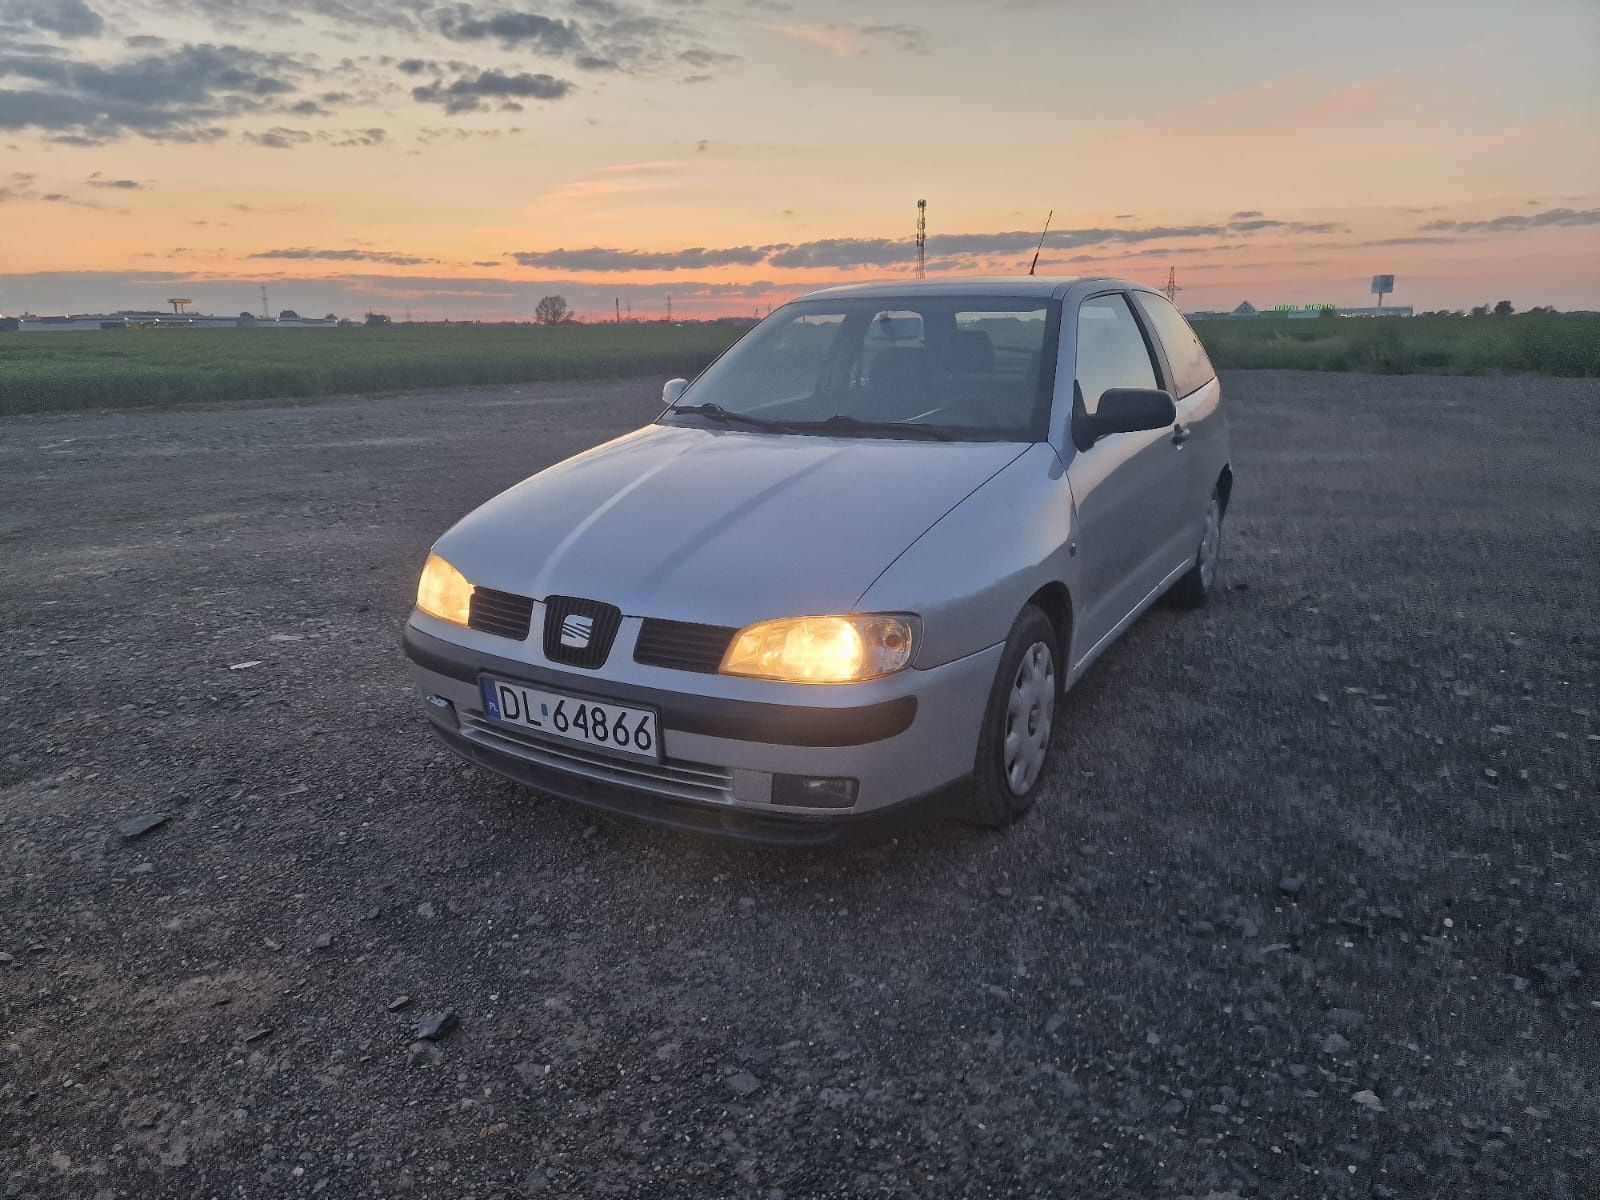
[0,325,742,414]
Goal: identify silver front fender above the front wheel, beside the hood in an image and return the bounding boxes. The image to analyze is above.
[856,443,1074,669]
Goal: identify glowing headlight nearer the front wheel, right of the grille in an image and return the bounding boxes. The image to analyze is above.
[720,613,917,683]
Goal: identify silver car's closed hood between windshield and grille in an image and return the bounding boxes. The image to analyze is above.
[435,426,1027,626]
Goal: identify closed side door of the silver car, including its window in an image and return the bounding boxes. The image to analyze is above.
[1067,291,1184,666]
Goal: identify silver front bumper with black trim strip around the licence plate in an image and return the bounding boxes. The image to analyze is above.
[403,613,1002,843]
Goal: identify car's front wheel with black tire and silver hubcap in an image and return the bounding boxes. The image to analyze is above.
[968,605,1062,829]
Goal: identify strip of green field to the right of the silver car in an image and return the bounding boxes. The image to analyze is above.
[1195,314,1600,376]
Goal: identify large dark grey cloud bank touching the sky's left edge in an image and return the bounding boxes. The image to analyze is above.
[0,45,306,146]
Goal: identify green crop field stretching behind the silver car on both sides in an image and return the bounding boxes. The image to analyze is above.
[0,315,1600,413]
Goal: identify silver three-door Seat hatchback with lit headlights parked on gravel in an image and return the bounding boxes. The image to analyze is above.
[405,277,1234,843]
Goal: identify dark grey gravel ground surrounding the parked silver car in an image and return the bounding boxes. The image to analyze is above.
[0,373,1600,1200]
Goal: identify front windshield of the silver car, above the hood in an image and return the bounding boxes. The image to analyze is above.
[661,296,1059,442]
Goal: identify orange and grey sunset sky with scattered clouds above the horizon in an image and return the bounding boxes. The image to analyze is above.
[0,0,1600,320]
